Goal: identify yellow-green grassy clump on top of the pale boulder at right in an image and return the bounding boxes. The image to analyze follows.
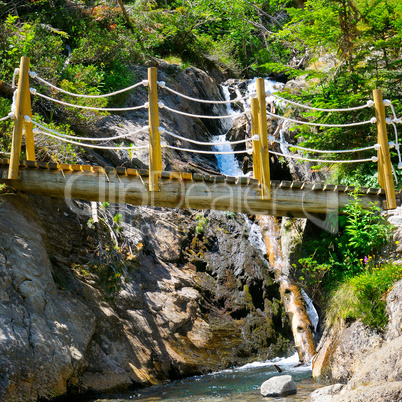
[326,263,402,329]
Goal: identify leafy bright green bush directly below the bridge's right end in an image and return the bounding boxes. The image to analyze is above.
[299,193,392,293]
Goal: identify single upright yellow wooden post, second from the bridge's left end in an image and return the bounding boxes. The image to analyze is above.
[148,67,162,191]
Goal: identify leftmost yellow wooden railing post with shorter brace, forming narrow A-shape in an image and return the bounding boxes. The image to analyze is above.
[8,56,35,180]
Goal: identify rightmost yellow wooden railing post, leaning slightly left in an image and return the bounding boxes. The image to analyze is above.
[373,89,396,209]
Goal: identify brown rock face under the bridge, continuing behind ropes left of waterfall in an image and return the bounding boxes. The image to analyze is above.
[0,61,292,402]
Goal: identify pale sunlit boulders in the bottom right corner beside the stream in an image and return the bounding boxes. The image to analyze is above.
[309,208,402,402]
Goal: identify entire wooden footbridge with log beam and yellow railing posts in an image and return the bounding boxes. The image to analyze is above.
[0,57,397,217]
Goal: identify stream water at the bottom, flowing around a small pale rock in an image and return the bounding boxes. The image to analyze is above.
[95,354,322,402]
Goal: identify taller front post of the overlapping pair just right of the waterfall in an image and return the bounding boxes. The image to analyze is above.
[256,78,271,200]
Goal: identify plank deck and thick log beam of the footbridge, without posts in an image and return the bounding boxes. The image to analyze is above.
[0,159,385,217]
